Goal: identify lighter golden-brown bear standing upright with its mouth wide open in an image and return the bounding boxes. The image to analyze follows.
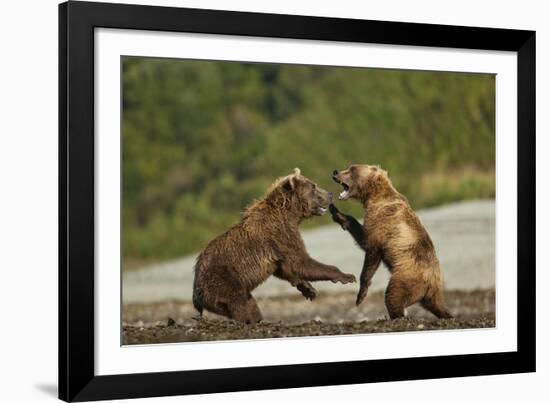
[330,165,452,319]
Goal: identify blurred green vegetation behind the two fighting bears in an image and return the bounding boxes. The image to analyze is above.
[123,57,495,268]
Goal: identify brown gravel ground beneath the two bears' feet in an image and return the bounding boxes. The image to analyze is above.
[122,289,495,344]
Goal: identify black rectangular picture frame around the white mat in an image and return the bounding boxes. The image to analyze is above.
[59,1,535,401]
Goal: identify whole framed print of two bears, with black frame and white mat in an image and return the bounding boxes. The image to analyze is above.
[59,1,535,401]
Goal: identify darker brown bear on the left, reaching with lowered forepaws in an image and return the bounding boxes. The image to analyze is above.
[193,168,355,323]
